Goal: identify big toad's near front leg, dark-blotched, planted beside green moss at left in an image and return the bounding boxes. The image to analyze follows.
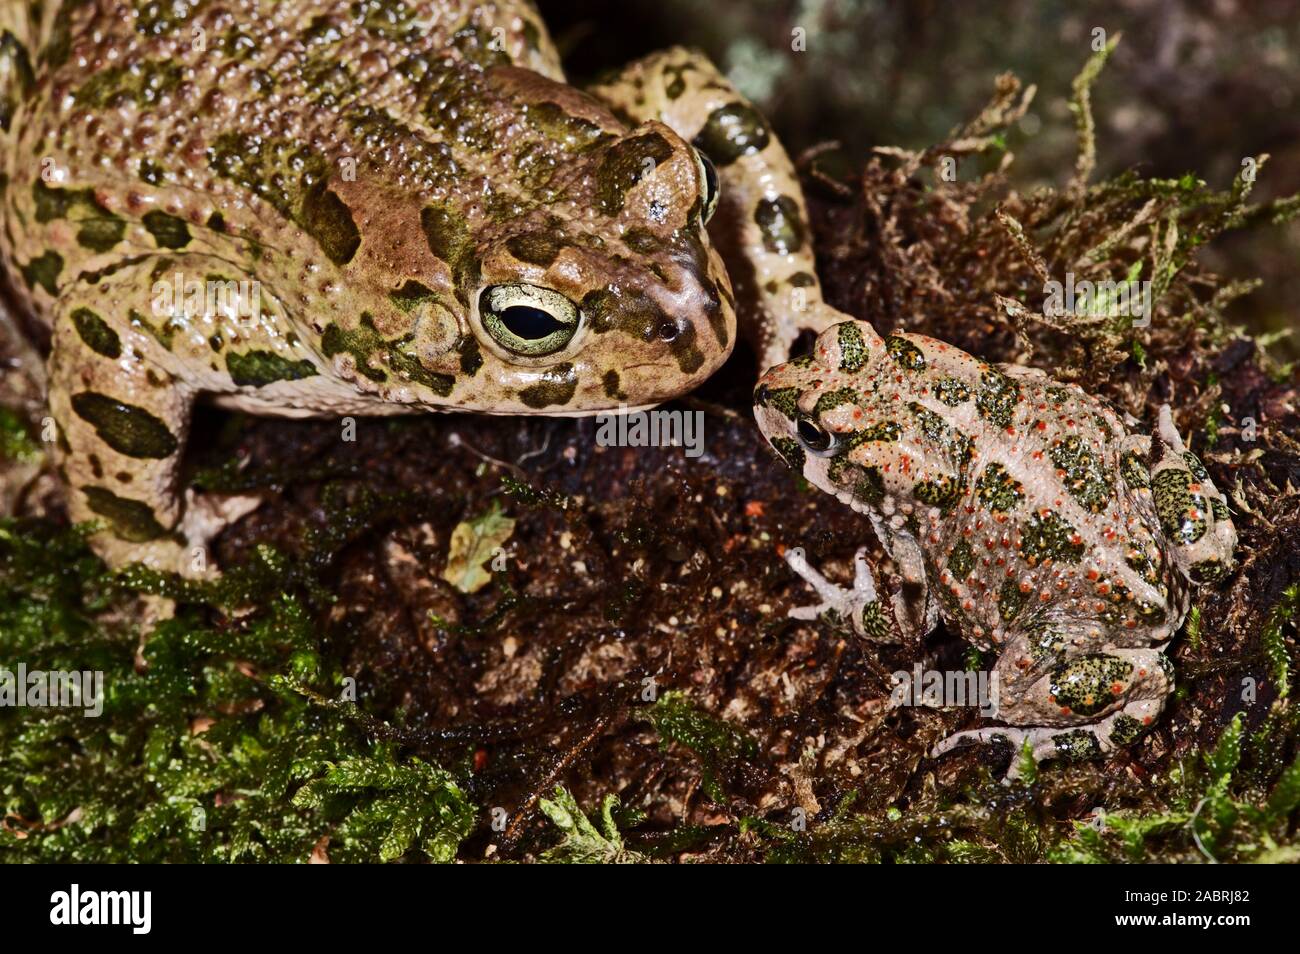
[49,256,289,577]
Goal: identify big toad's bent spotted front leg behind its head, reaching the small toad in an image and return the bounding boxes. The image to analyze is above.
[590,47,850,368]
